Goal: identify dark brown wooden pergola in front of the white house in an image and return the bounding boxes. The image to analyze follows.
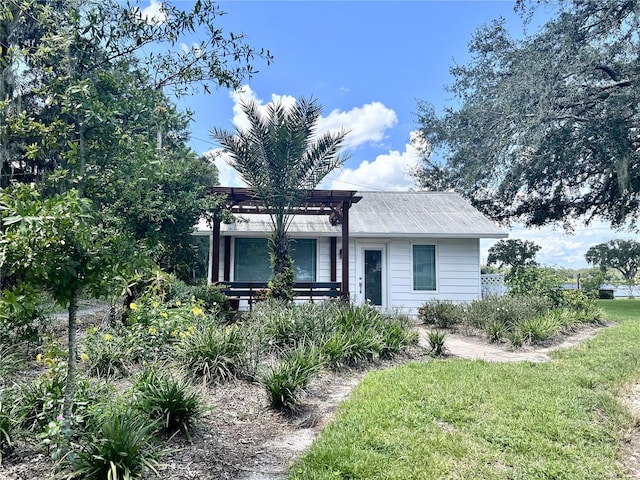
[210,187,362,297]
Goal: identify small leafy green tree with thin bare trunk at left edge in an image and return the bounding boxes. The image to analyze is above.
[0,185,136,428]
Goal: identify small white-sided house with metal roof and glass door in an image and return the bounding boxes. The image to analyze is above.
[196,188,507,314]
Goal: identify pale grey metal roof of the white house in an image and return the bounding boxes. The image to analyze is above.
[198,192,508,238]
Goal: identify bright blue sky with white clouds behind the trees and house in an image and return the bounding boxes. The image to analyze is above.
[141,0,630,268]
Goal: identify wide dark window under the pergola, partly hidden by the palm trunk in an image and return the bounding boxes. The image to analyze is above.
[234,238,316,282]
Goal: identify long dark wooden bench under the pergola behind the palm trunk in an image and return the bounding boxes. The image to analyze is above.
[220,282,342,310]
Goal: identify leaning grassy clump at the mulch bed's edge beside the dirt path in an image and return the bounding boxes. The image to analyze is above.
[261,346,322,411]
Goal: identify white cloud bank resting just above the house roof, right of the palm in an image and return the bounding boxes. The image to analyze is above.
[324,132,421,191]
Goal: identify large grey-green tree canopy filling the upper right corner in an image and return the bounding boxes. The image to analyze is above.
[417,0,640,226]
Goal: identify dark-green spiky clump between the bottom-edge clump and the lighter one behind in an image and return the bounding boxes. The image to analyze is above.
[135,369,202,439]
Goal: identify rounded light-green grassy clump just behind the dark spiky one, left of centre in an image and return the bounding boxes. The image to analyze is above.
[176,324,244,383]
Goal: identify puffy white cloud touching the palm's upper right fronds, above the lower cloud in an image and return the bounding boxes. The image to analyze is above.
[318,102,398,148]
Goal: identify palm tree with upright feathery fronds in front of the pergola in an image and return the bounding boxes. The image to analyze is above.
[211,98,347,300]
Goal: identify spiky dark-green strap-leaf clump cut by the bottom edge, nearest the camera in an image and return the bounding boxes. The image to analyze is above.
[68,405,160,480]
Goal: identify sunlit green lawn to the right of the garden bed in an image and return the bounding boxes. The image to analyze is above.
[290,300,640,480]
